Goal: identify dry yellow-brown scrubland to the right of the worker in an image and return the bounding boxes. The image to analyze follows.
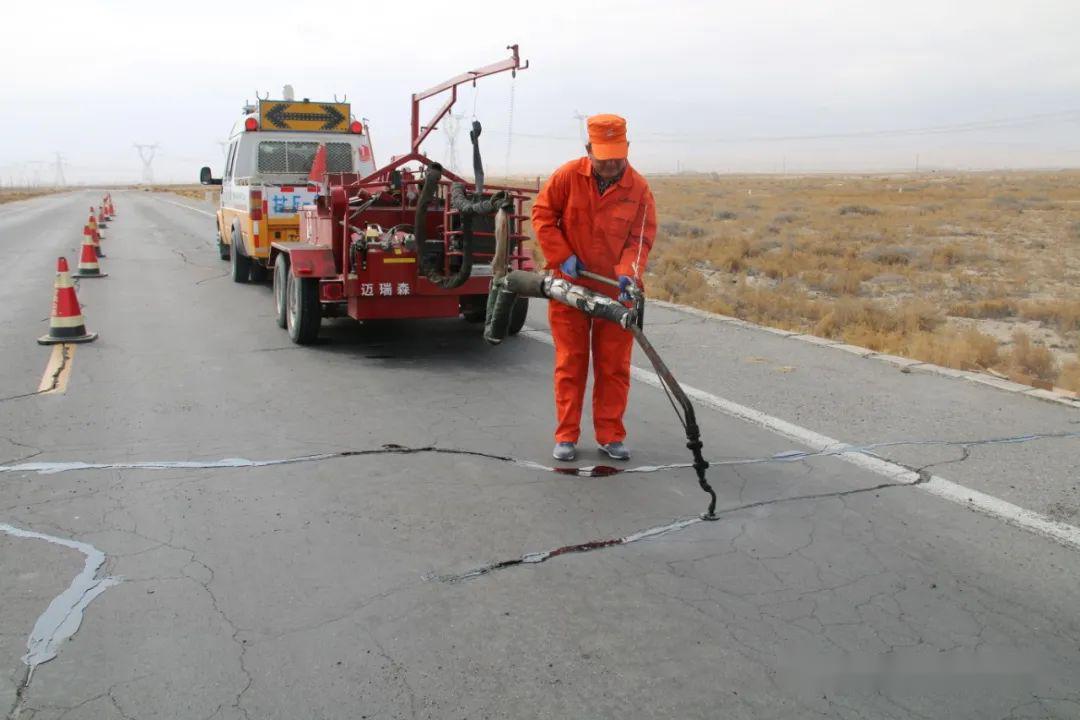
[647,172,1080,391]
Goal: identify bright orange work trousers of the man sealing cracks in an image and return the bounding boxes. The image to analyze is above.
[548,302,634,445]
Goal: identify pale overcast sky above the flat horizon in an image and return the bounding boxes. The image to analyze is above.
[0,0,1080,185]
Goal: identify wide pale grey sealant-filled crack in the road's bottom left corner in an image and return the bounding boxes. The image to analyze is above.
[0,522,121,682]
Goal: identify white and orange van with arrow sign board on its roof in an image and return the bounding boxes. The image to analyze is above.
[199,93,375,283]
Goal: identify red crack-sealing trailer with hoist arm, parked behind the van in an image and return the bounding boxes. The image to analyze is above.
[270,45,535,344]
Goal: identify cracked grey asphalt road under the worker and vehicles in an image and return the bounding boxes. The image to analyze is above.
[0,192,1080,720]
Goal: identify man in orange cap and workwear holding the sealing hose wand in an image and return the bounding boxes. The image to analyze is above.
[532,114,657,460]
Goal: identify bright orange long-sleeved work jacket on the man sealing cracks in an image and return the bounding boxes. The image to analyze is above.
[532,157,657,297]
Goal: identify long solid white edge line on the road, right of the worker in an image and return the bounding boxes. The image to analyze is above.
[521,328,1080,549]
